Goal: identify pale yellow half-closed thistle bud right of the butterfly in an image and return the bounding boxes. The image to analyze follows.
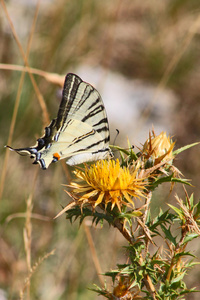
[142,132,175,165]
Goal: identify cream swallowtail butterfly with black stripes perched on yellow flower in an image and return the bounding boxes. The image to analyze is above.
[7,73,113,170]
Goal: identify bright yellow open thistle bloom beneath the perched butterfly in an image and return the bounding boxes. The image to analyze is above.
[71,159,145,211]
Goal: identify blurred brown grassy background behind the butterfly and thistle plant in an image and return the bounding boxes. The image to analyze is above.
[0,0,200,300]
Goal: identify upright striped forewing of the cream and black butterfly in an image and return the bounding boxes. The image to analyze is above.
[56,74,110,142]
